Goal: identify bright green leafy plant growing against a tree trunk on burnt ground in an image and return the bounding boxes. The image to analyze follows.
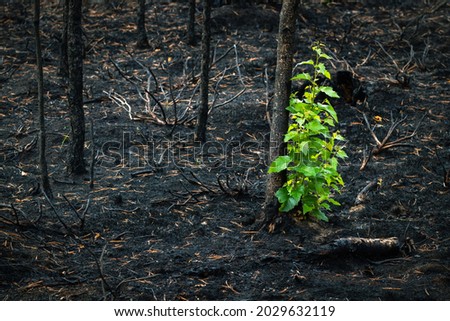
[269,44,347,221]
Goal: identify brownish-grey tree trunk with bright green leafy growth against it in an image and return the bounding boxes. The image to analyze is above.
[258,0,299,225]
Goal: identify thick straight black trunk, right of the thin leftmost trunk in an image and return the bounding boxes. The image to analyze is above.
[67,0,86,174]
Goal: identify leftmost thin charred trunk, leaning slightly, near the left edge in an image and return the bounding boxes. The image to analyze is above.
[34,0,52,198]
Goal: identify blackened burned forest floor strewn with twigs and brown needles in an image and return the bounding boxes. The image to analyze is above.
[0,1,450,300]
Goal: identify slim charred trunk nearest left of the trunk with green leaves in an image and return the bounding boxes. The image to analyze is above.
[195,0,211,143]
